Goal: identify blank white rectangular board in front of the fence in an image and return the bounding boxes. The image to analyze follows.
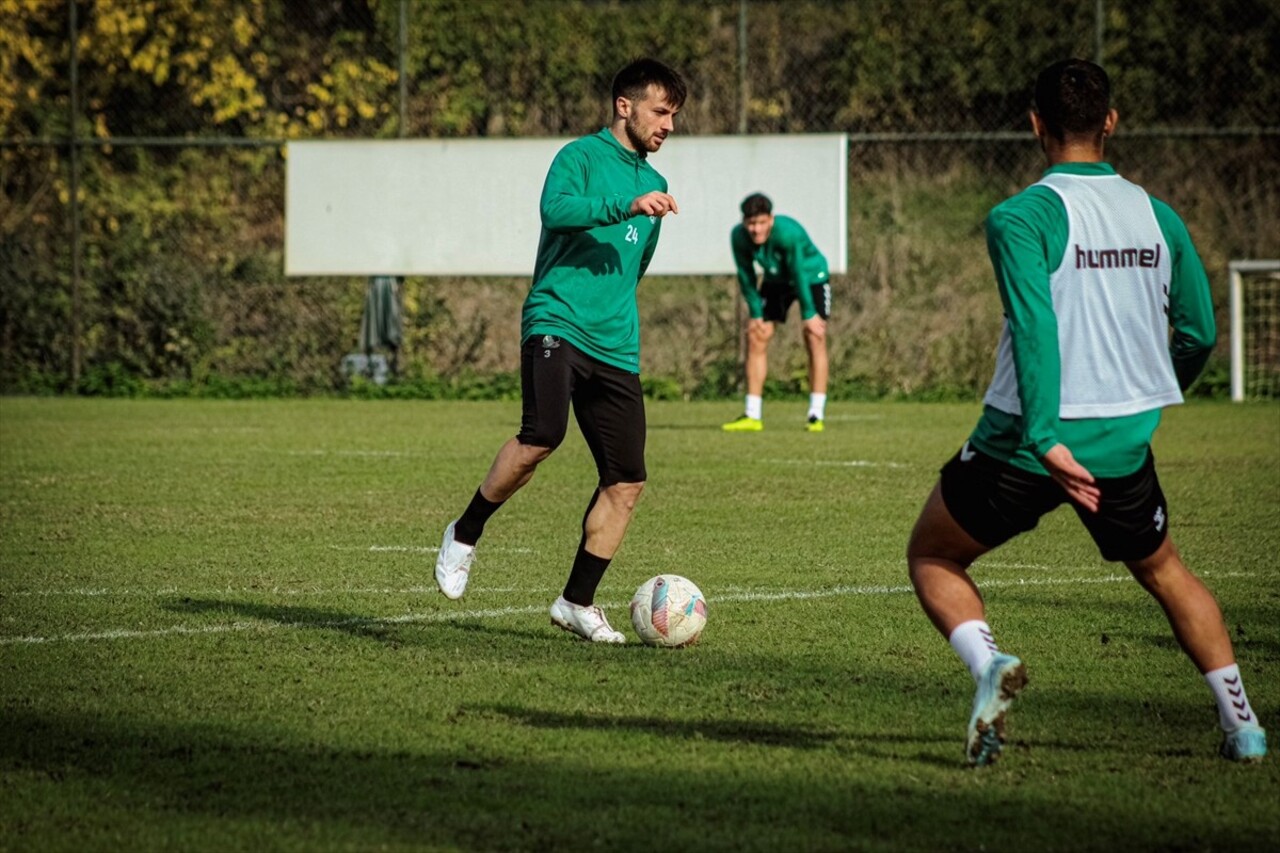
[284,133,849,275]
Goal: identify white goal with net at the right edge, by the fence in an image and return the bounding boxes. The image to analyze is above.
[1228,260,1280,402]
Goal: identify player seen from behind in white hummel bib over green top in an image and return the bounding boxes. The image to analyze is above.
[906,59,1267,765]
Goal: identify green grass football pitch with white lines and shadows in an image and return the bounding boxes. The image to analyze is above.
[0,398,1280,850]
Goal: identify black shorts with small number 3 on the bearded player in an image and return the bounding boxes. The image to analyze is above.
[516,334,646,485]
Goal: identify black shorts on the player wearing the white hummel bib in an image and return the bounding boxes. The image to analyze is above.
[942,442,1169,561]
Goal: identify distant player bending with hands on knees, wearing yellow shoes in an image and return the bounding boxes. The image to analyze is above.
[724,192,831,433]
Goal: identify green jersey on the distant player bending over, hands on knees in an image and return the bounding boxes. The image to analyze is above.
[730,215,829,320]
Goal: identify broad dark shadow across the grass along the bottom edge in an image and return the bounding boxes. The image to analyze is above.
[0,704,1277,850]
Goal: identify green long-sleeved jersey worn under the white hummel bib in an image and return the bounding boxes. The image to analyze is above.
[970,163,1216,476]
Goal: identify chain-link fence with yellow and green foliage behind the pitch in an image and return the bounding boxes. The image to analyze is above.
[0,0,1280,397]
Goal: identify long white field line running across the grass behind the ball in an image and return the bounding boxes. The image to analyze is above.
[0,571,1253,646]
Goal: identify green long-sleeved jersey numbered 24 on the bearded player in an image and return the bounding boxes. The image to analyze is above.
[520,128,667,373]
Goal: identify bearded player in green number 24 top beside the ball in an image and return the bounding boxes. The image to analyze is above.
[435,59,686,643]
